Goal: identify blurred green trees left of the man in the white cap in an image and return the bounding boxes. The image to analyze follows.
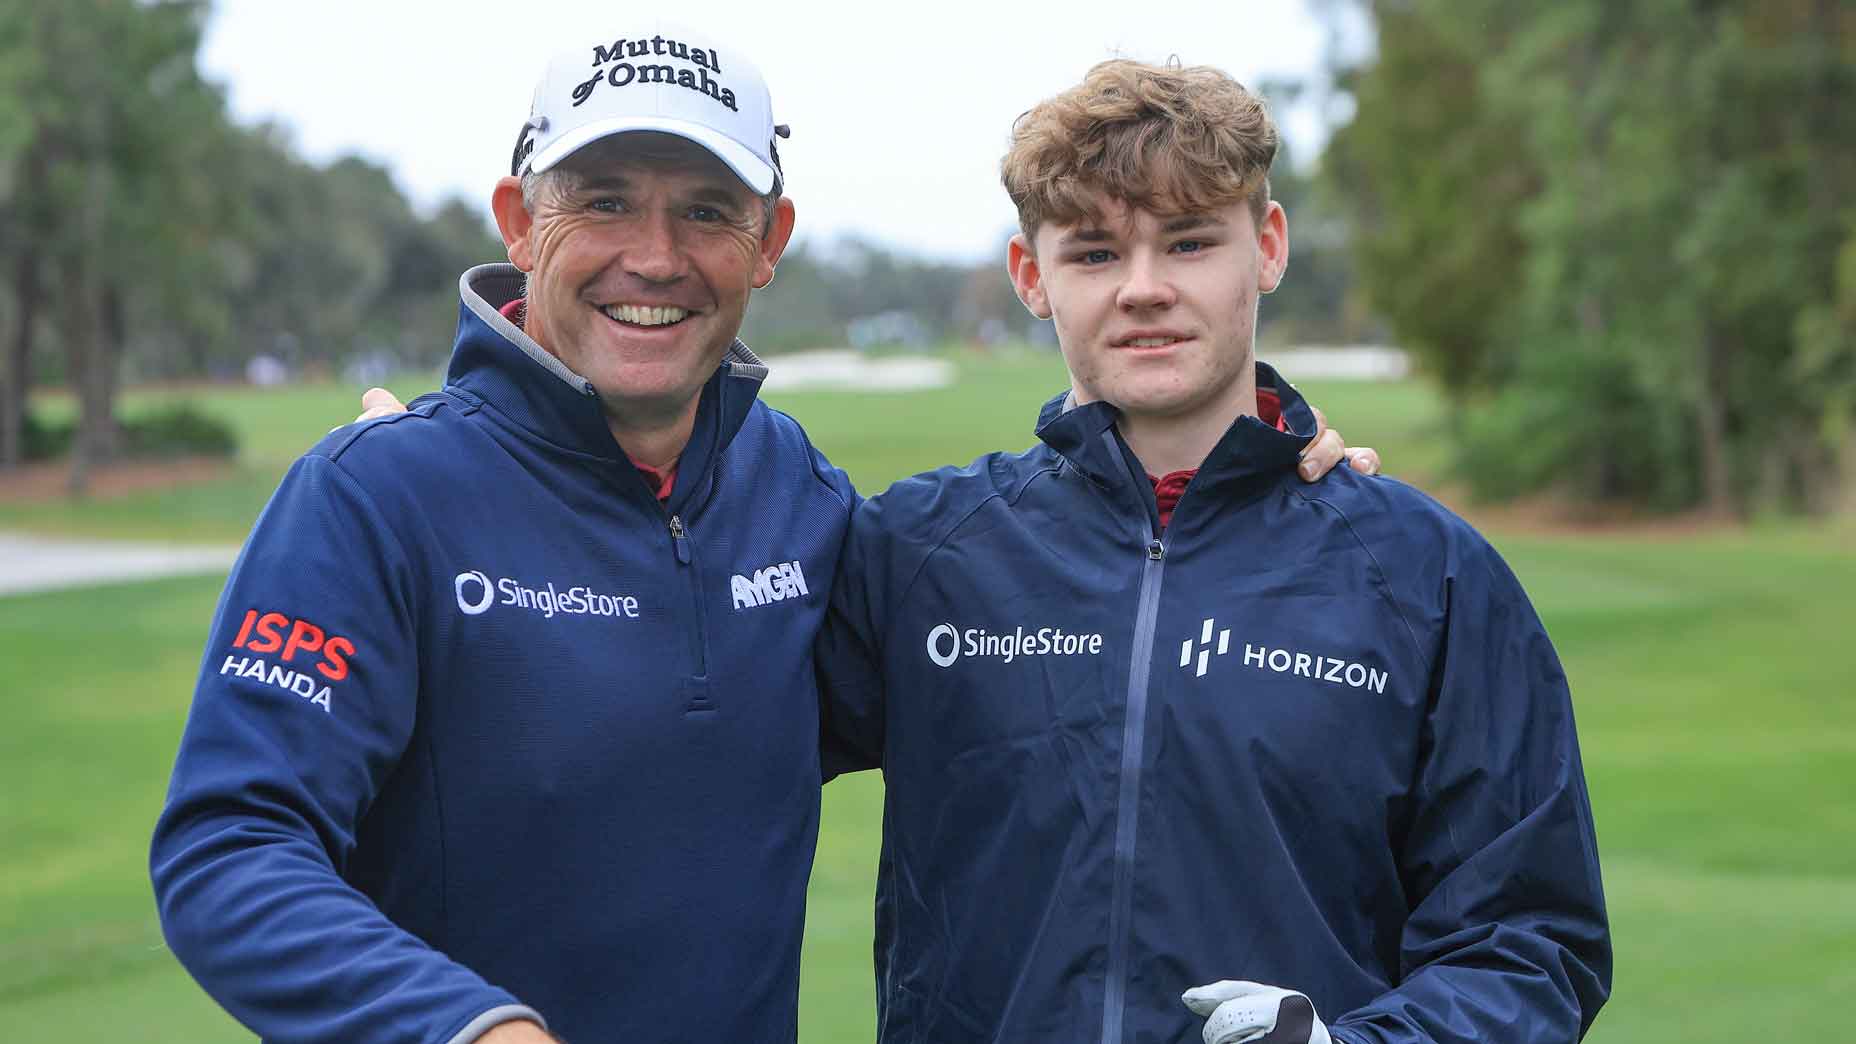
[0,0,501,489]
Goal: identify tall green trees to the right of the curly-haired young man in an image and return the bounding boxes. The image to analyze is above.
[1331,0,1856,513]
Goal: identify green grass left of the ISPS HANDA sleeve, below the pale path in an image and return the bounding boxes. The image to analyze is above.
[0,578,248,1040]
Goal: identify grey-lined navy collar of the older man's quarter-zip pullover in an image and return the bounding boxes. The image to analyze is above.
[445,264,767,509]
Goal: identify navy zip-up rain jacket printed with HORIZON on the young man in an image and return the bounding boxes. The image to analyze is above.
[820,366,1611,1044]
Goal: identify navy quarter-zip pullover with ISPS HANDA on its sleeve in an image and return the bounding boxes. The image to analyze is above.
[150,266,852,1042]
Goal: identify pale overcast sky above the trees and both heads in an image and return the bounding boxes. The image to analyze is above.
[200,0,1359,260]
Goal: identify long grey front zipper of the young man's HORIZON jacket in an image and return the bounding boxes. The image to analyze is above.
[1102,516,1166,1044]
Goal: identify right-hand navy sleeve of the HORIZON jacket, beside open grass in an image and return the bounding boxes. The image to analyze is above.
[1331,537,1611,1044]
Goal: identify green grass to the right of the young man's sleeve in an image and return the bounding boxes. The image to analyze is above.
[1498,531,1856,1042]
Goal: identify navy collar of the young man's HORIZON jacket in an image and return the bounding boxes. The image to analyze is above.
[1038,362,1314,496]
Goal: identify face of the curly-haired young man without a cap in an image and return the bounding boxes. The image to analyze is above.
[1008,188,1288,424]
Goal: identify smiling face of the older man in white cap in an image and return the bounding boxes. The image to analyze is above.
[497,132,793,427]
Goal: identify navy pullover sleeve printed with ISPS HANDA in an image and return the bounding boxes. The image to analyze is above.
[148,455,540,1042]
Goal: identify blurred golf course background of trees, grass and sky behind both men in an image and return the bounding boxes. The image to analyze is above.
[0,0,1856,1044]
